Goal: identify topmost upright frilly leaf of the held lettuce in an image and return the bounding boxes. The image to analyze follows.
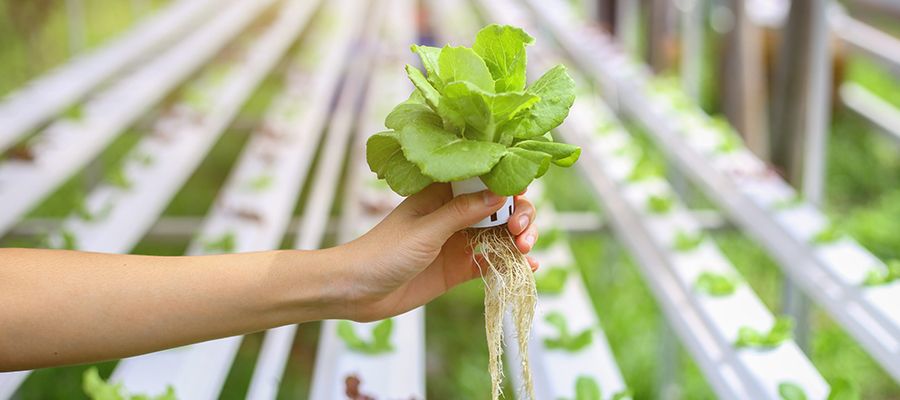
[472,25,534,93]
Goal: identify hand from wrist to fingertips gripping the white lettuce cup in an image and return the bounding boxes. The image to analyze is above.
[342,184,538,321]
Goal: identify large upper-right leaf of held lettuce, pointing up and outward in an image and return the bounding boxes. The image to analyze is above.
[504,65,575,139]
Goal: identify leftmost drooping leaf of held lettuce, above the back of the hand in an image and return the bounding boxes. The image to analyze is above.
[366,131,432,196]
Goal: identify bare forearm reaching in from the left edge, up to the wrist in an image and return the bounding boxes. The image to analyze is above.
[0,249,347,371]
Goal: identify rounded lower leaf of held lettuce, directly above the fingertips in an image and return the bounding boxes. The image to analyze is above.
[481,146,550,196]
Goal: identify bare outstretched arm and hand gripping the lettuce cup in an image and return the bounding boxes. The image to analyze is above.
[0,184,538,371]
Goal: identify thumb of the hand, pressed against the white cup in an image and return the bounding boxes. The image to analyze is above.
[422,190,506,242]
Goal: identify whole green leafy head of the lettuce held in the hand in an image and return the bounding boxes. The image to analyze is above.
[366,25,581,196]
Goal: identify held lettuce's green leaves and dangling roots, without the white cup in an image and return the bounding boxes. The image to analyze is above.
[366,25,581,399]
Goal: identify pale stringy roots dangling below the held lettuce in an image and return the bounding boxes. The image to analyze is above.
[469,225,537,400]
